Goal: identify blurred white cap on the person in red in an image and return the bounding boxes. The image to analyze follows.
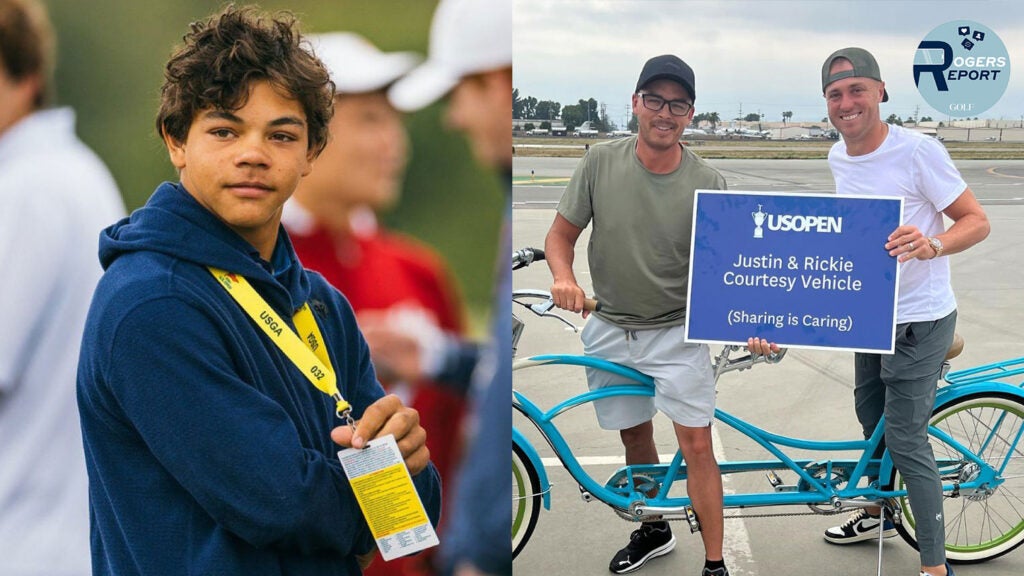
[307,32,423,94]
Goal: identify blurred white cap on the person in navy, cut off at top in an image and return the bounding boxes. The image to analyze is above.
[388,0,512,112]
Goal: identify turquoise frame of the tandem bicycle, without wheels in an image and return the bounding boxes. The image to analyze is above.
[513,355,1021,521]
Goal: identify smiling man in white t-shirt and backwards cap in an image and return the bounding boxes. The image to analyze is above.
[752,48,989,576]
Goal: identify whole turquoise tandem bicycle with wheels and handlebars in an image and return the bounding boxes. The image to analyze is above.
[512,243,1024,561]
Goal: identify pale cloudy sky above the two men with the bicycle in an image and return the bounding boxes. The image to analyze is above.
[513,0,1024,126]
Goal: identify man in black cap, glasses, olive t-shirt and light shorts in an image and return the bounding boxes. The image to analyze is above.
[545,54,728,576]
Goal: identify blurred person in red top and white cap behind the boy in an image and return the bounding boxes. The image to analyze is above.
[282,32,475,576]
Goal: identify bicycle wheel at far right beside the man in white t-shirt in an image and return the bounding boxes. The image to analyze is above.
[890,393,1024,564]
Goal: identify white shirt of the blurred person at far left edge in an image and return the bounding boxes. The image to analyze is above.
[0,109,124,576]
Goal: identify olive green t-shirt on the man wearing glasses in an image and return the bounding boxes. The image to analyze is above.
[558,136,726,329]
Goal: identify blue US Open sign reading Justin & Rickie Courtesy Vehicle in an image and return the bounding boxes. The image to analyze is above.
[686,190,903,353]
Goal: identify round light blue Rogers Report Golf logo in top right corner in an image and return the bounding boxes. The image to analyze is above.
[913,20,1010,118]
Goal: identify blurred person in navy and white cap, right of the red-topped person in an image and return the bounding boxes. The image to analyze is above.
[388,0,512,576]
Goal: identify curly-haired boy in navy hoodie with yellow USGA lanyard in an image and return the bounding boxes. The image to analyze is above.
[78,7,440,576]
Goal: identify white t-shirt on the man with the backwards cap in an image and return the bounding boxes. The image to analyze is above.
[828,125,967,324]
